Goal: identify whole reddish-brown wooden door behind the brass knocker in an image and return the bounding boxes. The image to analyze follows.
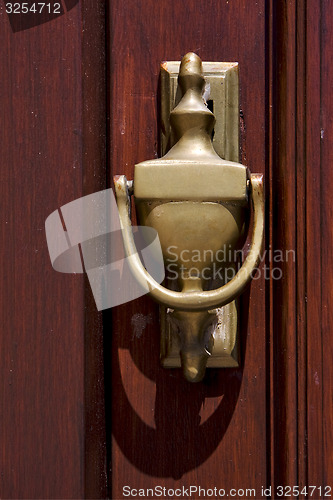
[0,0,333,499]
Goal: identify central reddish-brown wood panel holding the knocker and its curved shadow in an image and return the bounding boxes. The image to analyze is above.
[109,0,267,498]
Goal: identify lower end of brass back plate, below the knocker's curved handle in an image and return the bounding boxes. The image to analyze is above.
[160,300,239,368]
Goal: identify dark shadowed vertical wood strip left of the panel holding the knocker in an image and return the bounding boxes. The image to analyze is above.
[80,0,107,499]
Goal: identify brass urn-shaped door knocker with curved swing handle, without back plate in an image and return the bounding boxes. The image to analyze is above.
[114,53,264,382]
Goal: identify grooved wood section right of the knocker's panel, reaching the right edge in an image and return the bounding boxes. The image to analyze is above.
[272,0,333,496]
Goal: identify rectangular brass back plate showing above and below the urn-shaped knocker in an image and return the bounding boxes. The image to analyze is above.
[160,61,239,368]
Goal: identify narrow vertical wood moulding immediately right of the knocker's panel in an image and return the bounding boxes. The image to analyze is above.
[272,2,297,485]
